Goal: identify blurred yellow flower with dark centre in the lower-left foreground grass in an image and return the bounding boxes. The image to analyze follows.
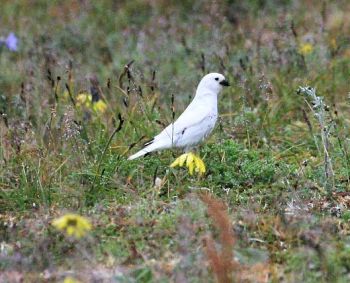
[52,214,92,238]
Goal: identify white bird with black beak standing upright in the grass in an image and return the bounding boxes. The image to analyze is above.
[128,73,229,160]
